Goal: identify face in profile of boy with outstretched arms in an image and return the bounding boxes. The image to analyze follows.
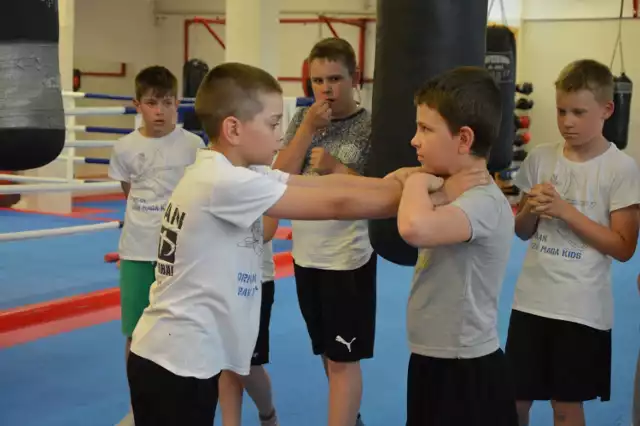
[237,93,283,166]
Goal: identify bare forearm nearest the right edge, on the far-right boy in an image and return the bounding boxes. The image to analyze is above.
[560,206,633,262]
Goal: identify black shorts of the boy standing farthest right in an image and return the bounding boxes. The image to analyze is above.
[505,310,611,402]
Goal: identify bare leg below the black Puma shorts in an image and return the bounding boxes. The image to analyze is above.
[327,360,362,426]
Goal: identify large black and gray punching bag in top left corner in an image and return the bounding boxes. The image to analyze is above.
[0,0,65,171]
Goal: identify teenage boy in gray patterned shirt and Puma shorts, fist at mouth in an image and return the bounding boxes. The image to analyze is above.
[274,38,370,426]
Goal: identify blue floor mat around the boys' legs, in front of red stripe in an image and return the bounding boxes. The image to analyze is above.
[0,242,640,426]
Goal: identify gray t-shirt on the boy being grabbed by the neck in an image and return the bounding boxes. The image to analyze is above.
[407,183,514,358]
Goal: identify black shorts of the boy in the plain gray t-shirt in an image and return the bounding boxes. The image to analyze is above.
[407,349,518,426]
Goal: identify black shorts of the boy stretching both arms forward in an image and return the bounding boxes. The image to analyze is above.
[127,352,219,426]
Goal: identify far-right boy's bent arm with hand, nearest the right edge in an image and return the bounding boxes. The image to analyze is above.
[536,184,638,262]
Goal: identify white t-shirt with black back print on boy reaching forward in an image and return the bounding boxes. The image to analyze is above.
[131,150,289,379]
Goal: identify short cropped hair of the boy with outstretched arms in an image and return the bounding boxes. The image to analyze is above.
[195,62,282,141]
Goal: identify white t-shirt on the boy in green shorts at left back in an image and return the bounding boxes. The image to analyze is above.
[109,127,204,261]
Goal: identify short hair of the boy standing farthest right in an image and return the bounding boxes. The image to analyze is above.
[555,59,614,102]
